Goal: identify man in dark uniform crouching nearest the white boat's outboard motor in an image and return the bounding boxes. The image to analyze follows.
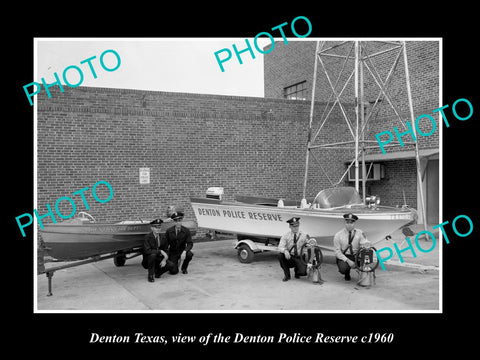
[165,211,193,275]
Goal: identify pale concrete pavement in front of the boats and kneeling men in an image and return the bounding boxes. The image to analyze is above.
[37,229,441,312]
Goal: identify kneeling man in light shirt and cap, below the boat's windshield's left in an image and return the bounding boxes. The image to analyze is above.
[278,217,307,281]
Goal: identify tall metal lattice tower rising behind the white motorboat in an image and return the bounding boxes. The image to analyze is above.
[303,41,427,226]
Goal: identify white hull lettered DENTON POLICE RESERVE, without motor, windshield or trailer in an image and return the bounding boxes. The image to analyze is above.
[191,198,415,246]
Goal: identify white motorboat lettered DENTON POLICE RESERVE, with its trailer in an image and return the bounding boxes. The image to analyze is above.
[190,187,417,262]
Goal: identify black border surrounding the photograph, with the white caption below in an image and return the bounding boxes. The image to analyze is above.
[6,2,480,357]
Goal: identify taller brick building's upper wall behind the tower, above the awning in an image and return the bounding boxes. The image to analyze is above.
[264,41,441,153]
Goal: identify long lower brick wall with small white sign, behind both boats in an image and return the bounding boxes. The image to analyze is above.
[37,87,346,235]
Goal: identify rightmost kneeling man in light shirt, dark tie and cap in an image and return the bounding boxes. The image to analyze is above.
[333,213,370,281]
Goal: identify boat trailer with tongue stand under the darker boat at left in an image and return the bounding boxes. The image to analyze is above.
[37,246,143,296]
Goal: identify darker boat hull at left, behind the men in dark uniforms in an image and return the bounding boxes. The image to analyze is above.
[40,221,196,261]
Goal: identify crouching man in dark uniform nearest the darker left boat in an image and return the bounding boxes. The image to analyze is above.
[142,219,171,282]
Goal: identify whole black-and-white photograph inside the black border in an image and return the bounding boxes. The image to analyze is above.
[32,37,442,312]
